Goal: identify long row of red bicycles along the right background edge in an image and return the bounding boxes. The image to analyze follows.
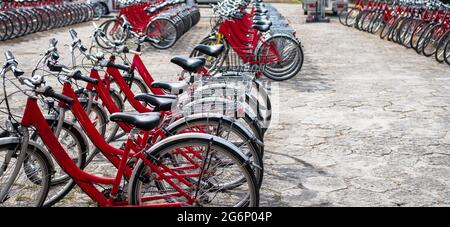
[339,0,450,65]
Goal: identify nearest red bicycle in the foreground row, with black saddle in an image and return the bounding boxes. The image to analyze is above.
[0,52,258,206]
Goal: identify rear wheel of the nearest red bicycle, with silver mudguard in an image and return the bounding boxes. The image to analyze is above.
[129,133,259,207]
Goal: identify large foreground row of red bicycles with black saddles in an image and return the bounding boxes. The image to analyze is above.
[0,1,298,206]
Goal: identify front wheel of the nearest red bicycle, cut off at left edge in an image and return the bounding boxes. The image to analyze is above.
[0,138,52,207]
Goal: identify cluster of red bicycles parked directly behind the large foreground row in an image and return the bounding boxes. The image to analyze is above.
[191,0,303,81]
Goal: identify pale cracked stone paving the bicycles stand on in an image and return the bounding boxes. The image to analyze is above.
[0,4,450,206]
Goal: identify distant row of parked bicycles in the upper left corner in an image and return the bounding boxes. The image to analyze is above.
[0,0,94,40]
